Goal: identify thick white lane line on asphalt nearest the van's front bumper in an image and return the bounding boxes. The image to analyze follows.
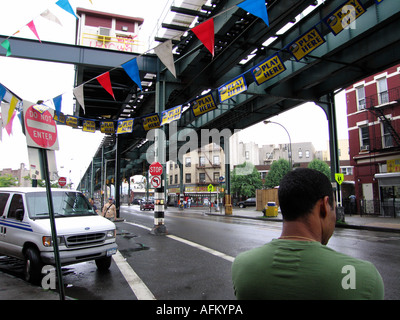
[112,251,156,300]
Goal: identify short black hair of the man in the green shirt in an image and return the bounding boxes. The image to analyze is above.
[278,168,333,221]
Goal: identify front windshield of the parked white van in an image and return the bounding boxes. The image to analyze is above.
[26,191,97,219]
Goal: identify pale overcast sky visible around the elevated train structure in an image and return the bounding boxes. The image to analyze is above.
[0,0,347,183]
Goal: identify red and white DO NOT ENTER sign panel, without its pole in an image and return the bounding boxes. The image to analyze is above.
[24,106,58,150]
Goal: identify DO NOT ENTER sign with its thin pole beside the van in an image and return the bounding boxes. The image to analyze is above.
[24,105,65,300]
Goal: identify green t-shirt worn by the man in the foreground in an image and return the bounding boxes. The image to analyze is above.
[232,239,384,300]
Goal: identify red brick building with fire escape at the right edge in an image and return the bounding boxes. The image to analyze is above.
[346,65,400,216]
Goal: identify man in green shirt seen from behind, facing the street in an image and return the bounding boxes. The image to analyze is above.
[232,168,384,300]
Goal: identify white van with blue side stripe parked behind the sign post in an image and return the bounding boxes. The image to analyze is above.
[0,188,117,283]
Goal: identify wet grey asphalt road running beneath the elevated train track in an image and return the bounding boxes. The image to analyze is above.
[0,206,400,301]
